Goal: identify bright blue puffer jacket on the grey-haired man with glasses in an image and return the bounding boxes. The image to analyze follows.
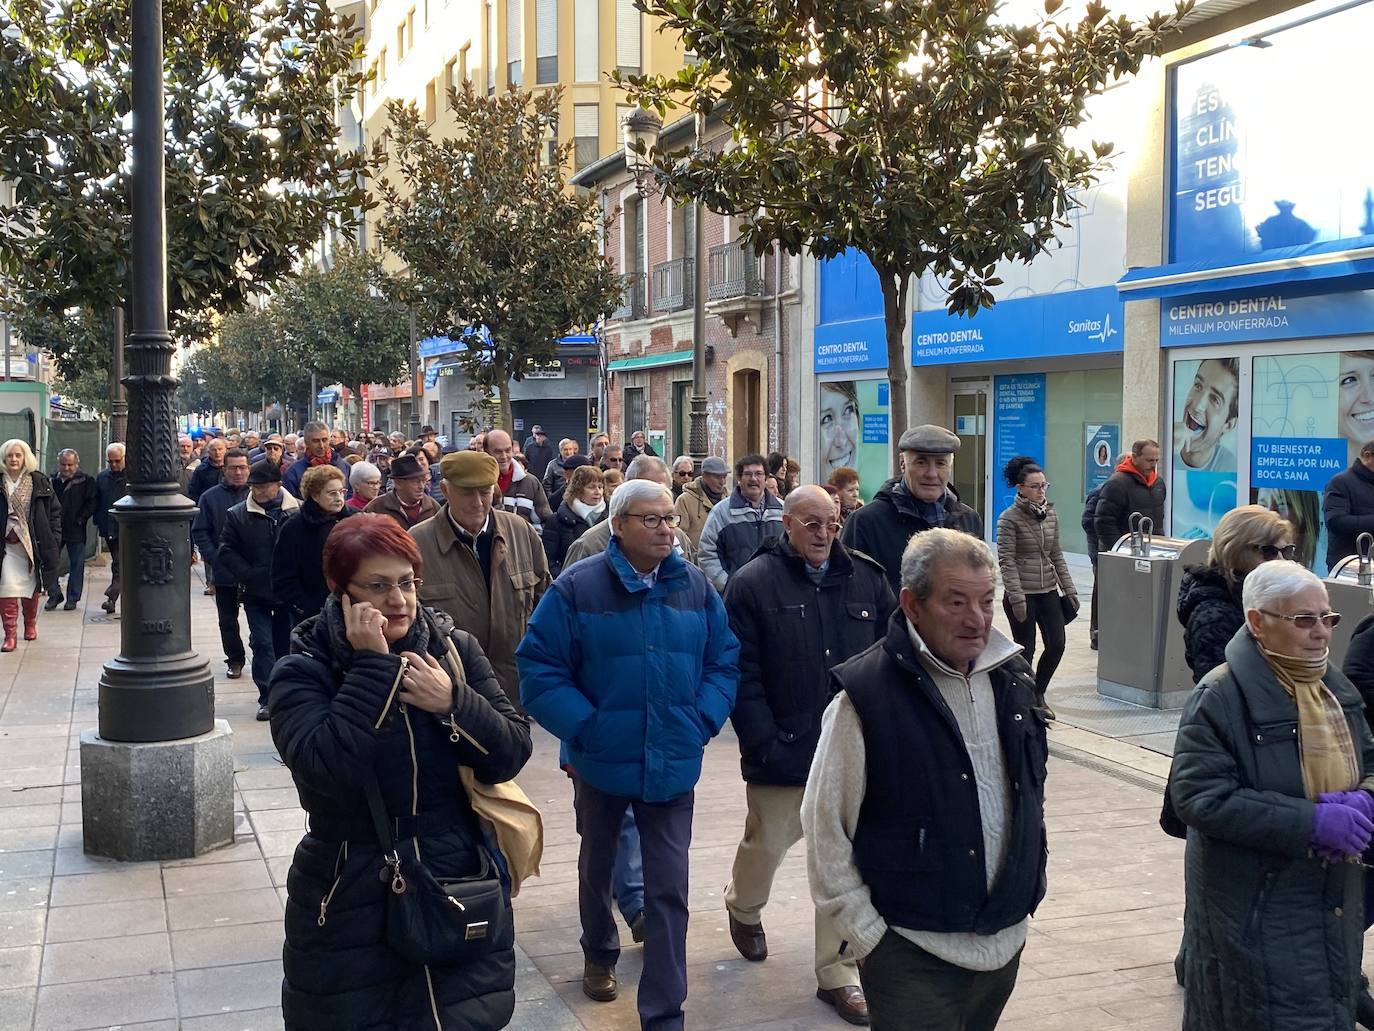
[515,539,739,801]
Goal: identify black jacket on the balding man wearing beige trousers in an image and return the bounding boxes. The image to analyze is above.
[725,537,897,786]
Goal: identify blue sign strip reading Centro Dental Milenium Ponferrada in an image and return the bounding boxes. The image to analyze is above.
[1160,287,1374,348]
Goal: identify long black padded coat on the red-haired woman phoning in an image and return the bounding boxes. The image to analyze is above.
[271,597,530,1031]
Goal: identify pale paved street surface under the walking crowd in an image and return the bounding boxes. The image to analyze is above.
[0,568,1286,1031]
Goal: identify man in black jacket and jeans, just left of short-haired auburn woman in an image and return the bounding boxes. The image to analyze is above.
[216,462,300,720]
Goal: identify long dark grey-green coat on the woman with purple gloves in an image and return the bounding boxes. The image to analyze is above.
[1169,630,1374,1031]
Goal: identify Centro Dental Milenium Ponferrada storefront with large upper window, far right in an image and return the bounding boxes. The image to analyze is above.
[1118,4,1374,572]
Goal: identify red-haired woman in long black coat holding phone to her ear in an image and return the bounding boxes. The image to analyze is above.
[271,514,530,1031]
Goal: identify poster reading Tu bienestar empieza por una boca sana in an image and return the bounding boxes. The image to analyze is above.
[1250,351,1374,575]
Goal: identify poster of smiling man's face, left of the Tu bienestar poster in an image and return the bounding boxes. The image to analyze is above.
[1168,357,1241,539]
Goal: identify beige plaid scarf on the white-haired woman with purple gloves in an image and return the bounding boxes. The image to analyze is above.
[1254,641,1360,801]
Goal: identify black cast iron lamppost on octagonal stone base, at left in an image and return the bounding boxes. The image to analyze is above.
[81,0,234,859]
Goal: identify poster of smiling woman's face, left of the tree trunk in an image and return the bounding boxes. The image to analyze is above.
[816,379,892,502]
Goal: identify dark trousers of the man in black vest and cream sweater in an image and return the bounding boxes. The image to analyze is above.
[859,929,1021,1031]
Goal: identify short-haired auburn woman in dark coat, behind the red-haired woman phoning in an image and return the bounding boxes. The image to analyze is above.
[272,466,357,625]
